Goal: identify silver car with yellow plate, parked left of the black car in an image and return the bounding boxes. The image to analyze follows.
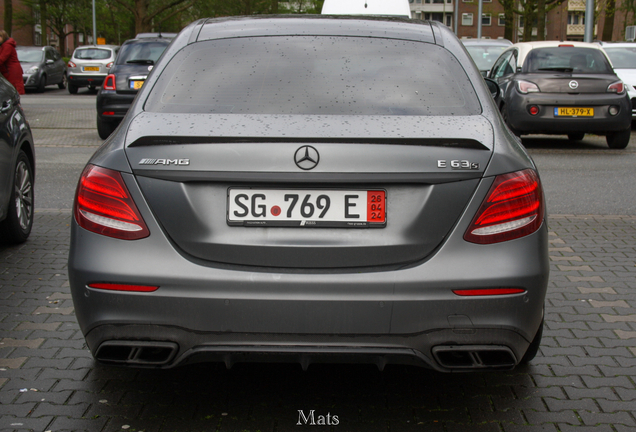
[68,45,119,94]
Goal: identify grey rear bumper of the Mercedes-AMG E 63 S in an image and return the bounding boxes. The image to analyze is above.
[69,175,549,371]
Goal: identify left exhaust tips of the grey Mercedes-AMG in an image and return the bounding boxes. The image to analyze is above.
[95,341,179,366]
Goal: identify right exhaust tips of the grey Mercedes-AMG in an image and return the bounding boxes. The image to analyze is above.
[433,345,517,370]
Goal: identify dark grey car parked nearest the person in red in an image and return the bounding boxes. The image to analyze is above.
[16,46,66,92]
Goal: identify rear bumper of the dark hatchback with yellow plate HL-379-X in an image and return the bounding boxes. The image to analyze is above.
[506,89,632,135]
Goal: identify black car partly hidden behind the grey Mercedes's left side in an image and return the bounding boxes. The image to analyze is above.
[97,33,176,139]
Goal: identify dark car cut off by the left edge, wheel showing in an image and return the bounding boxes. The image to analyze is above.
[0,75,35,243]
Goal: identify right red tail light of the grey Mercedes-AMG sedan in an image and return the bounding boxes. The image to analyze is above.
[464,169,545,244]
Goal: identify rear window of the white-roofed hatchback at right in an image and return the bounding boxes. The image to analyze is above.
[524,46,612,74]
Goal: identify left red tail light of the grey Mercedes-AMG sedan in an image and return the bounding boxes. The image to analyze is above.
[74,165,150,240]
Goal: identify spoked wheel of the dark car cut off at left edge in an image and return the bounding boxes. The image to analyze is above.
[0,150,34,243]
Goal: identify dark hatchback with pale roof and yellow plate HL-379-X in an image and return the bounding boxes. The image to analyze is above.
[489,41,632,149]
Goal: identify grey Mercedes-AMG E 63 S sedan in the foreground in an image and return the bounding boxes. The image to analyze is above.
[69,16,549,372]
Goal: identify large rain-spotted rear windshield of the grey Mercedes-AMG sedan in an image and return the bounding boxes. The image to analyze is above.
[145,36,481,115]
